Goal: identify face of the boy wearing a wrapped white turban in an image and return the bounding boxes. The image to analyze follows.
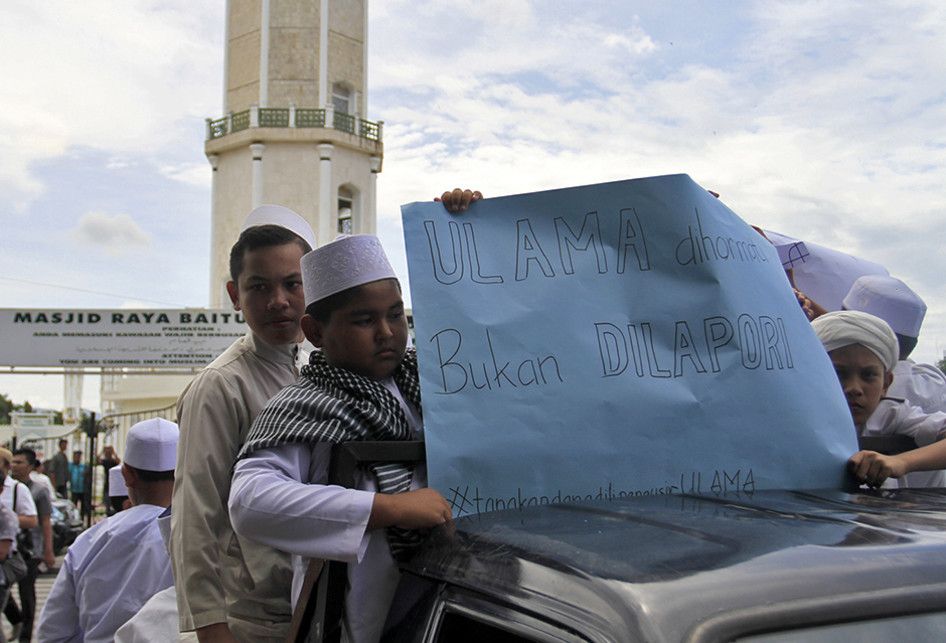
[828,344,893,426]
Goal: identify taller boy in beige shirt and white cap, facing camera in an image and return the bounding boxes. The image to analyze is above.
[171,205,315,642]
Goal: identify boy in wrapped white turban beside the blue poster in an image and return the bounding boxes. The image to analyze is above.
[811,311,946,487]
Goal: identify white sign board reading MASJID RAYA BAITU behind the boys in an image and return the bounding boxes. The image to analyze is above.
[0,308,247,369]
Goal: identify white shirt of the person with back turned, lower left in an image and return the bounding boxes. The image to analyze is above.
[37,505,174,643]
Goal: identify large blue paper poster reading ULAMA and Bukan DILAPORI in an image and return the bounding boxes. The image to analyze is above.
[402,175,857,516]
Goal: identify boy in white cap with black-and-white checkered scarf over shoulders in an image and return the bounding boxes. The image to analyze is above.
[230,235,450,642]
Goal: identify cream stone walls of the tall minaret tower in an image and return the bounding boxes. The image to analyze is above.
[205,0,383,306]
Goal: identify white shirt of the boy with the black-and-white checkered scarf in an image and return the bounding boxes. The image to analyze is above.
[229,381,427,643]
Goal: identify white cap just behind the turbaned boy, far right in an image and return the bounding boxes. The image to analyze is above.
[844,275,926,337]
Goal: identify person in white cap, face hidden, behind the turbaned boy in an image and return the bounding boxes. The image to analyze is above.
[844,275,946,413]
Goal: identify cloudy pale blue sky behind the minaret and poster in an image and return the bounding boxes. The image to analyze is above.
[0,0,946,409]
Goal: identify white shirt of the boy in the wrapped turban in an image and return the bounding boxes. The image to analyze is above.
[861,397,946,489]
